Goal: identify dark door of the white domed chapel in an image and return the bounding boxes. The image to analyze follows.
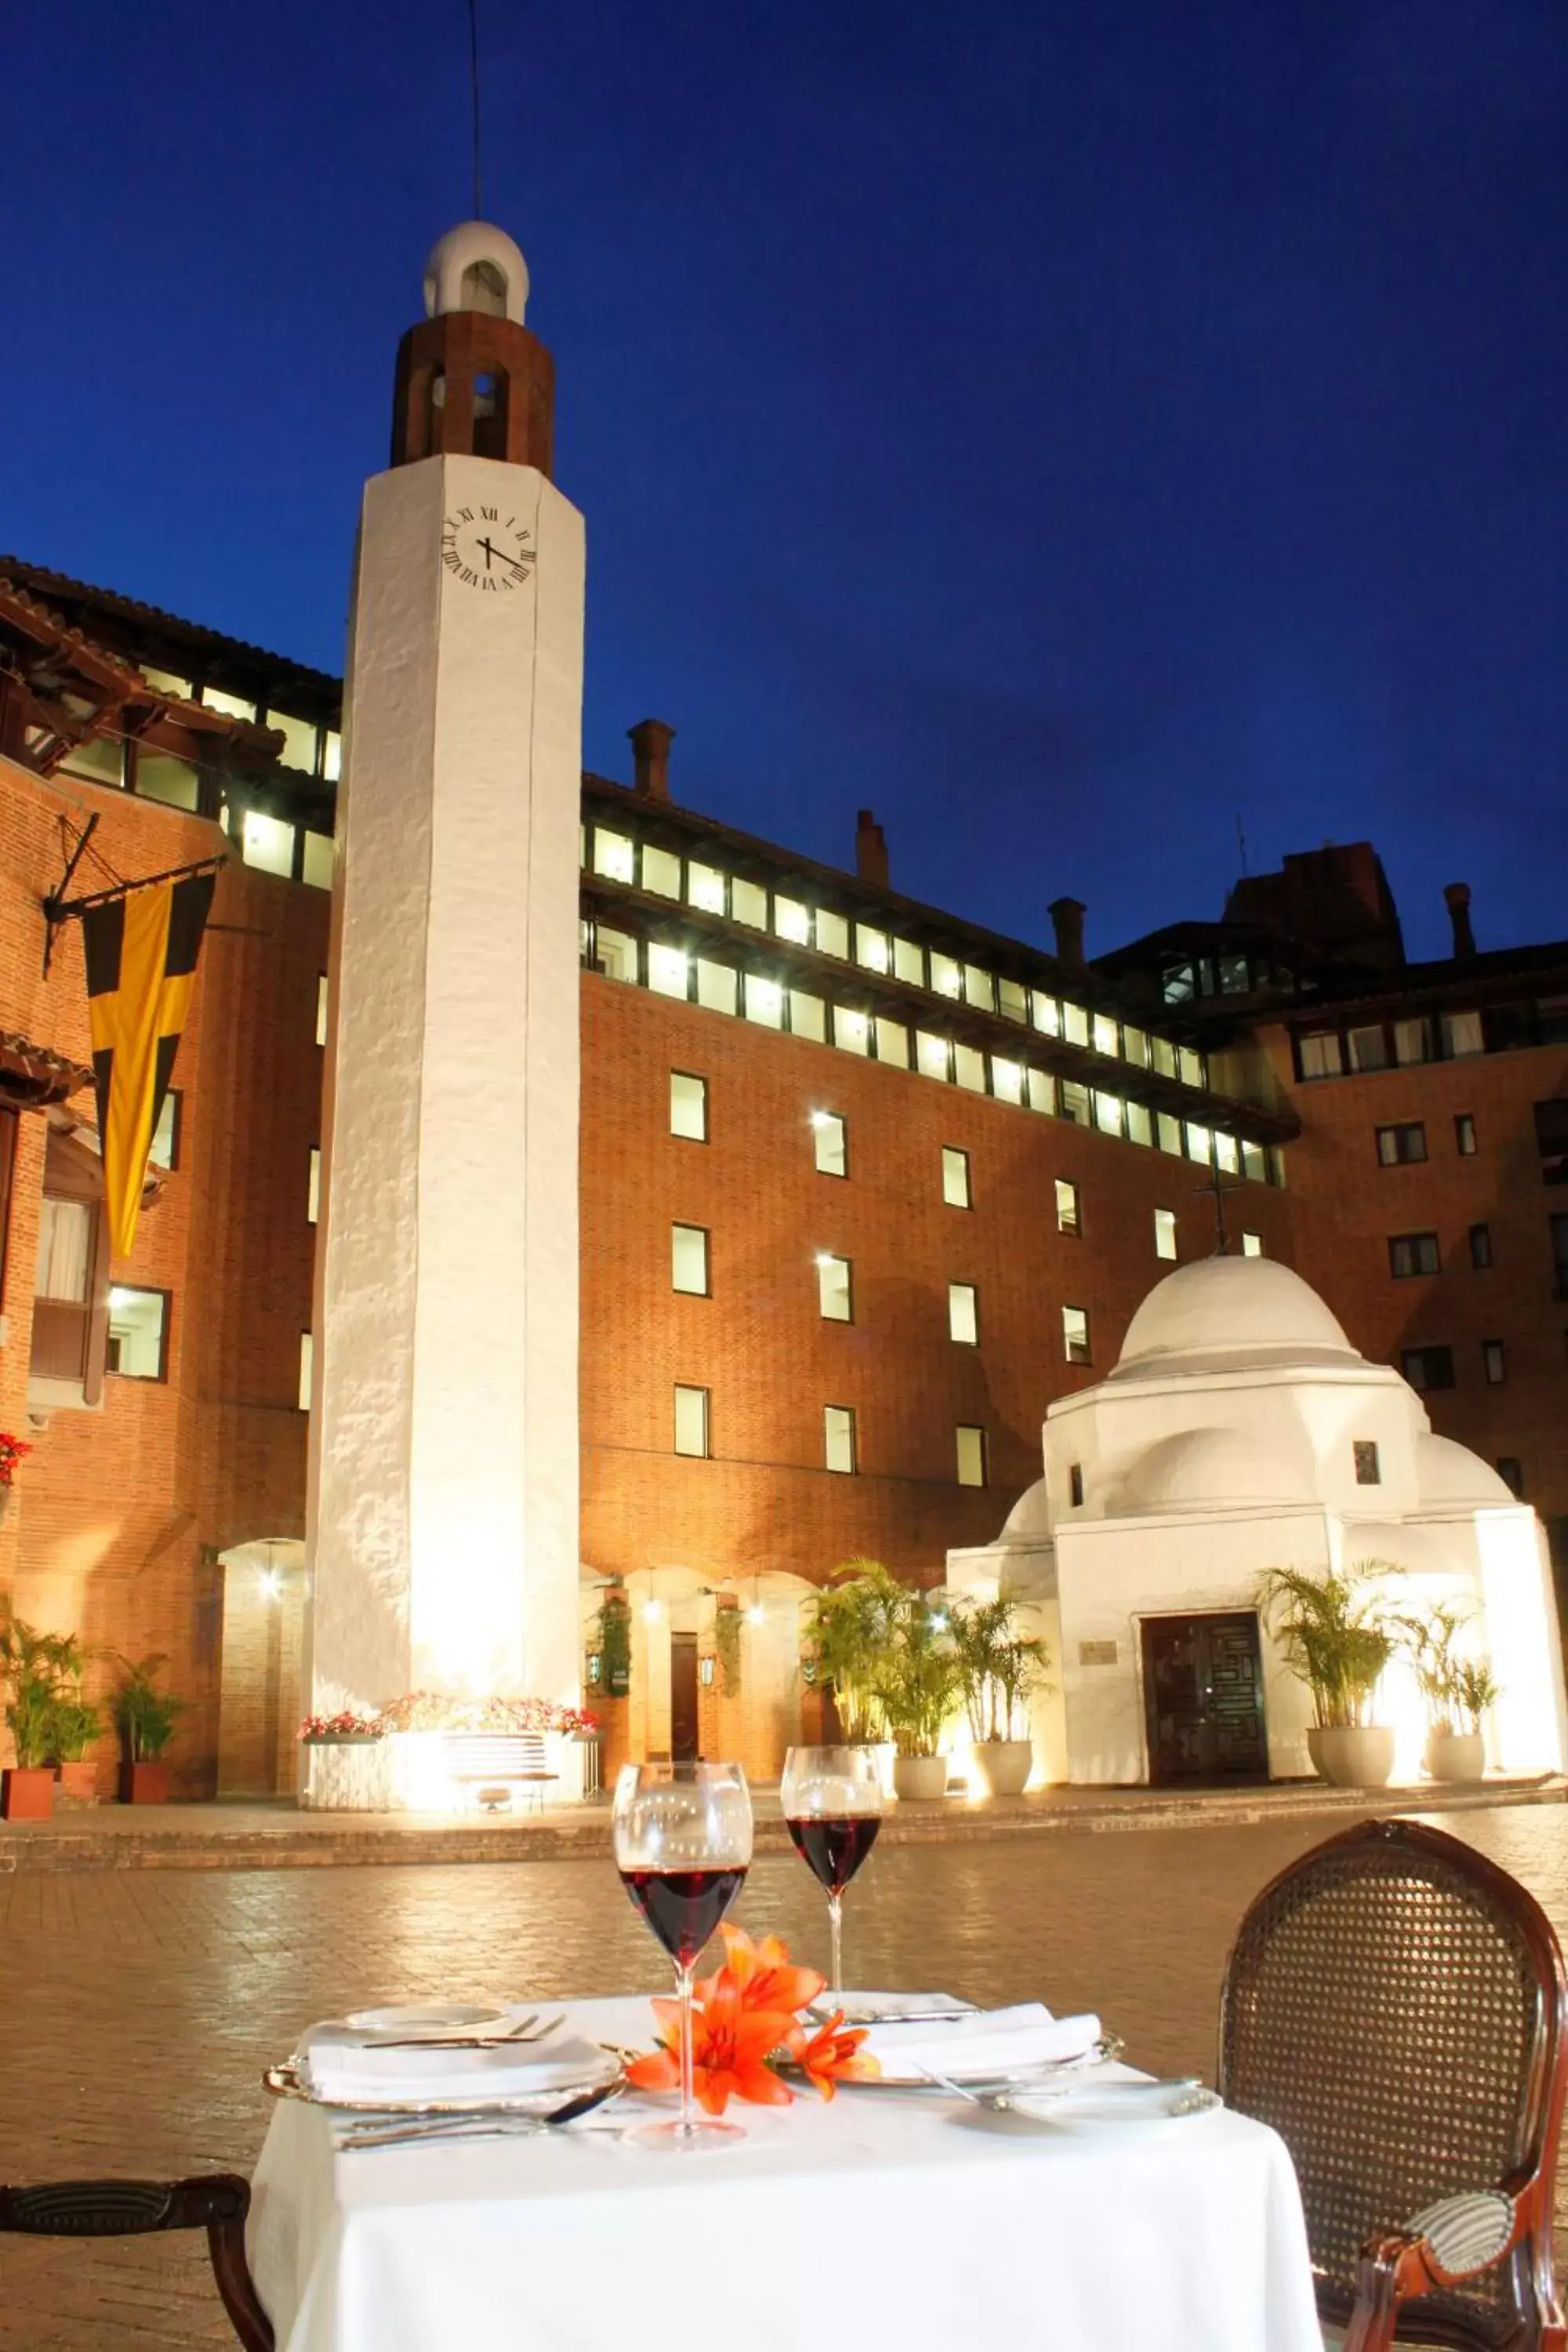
[1142,1611,1269,1788]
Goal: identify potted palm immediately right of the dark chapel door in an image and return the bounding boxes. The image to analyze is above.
[1258,1559,1399,1788]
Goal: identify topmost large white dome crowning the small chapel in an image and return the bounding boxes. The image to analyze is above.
[1109,1258,1363,1381]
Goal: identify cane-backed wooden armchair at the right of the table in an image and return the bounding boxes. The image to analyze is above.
[1220,1820,1568,2352]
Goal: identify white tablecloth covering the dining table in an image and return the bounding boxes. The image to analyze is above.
[252,1999,1321,2352]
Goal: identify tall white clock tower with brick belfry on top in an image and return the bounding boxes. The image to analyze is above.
[306,221,583,1750]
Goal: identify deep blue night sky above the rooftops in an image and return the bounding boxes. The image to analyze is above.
[0,0,1568,955]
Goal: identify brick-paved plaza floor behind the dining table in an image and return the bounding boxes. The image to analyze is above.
[0,1804,1568,2352]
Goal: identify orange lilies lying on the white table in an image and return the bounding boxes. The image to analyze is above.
[626,1926,881,2114]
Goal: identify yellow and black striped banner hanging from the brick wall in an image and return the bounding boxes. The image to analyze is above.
[82,873,216,1258]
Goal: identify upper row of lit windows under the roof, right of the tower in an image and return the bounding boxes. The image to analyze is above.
[583,826,1203,1087]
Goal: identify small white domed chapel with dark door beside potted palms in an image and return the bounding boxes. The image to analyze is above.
[947,1258,1568,1783]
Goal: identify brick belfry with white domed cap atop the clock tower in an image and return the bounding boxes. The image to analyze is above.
[393,221,555,480]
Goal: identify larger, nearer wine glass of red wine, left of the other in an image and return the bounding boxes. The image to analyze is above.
[612,1764,753,2152]
